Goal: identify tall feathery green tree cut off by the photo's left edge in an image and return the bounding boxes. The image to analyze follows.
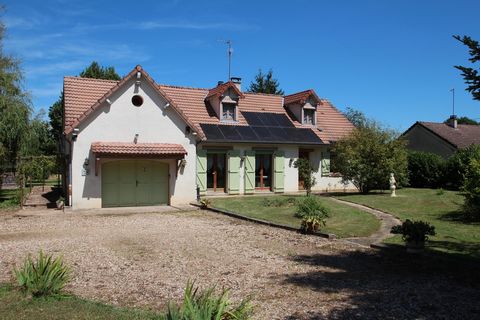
[0,8,31,166]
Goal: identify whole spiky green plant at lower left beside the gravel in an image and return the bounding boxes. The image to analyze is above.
[13,250,70,297]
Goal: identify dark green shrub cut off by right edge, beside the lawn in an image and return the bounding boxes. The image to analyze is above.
[463,159,480,220]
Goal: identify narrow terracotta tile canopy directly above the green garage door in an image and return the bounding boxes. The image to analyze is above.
[92,142,187,156]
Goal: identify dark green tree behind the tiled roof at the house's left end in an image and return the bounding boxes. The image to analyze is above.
[48,61,120,146]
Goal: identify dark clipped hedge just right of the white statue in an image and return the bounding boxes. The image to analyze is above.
[408,151,446,188]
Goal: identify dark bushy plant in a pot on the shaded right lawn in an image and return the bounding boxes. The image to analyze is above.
[390,219,436,253]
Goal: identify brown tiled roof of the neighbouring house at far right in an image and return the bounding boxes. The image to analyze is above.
[416,121,480,148]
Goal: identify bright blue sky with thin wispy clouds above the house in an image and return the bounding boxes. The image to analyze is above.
[2,0,480,130]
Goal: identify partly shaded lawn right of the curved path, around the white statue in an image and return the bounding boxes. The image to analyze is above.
[338,188,480,258]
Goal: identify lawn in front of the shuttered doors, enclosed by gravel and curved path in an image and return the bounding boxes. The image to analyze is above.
[212,196,380,238]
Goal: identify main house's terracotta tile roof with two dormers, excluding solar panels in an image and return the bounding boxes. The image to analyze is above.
[64,66,353,143]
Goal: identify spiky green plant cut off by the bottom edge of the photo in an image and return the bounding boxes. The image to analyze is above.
[161,281,252,320]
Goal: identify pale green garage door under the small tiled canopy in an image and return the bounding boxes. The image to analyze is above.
[102,160,168,207]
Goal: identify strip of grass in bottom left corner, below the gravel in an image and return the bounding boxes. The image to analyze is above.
[0,285,158,320]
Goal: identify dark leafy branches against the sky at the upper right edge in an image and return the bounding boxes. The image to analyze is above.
[453,35,480,100]
